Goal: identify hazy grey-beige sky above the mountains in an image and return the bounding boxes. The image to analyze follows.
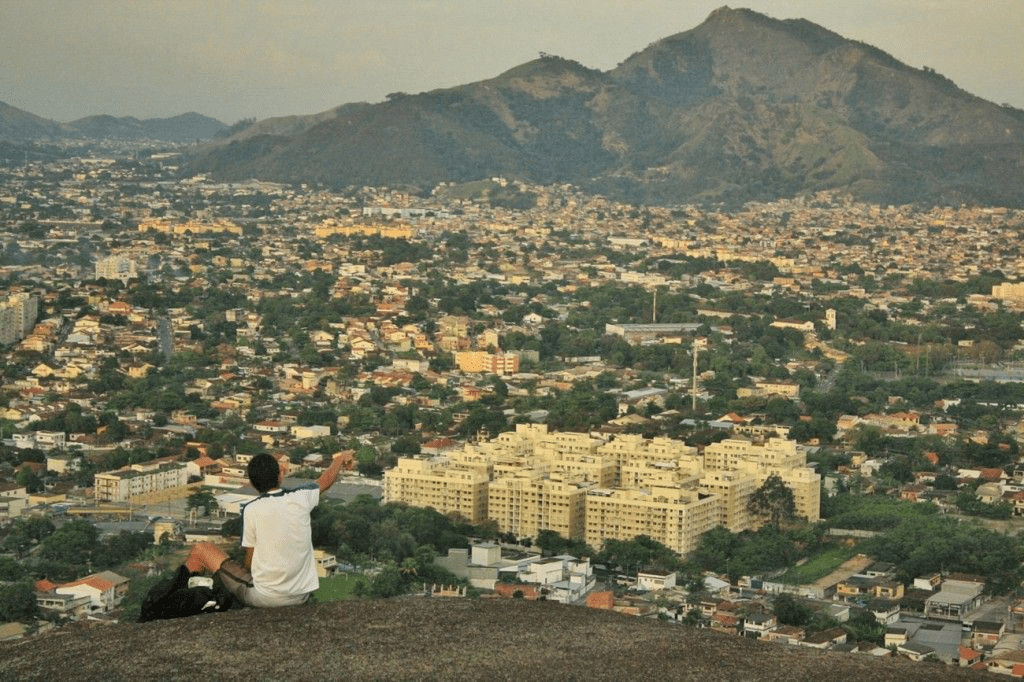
[6,0,1024,123]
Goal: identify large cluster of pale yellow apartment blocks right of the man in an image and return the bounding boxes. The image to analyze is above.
[384,424,821,554]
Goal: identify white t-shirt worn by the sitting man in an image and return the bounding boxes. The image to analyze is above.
[242,483,319,599]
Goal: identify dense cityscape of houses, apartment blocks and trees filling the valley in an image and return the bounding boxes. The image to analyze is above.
[0,139,1024,672]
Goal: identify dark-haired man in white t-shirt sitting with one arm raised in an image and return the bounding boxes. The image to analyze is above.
[184,454,343,606]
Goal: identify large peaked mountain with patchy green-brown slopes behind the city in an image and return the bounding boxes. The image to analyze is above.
[191,7,1024,206]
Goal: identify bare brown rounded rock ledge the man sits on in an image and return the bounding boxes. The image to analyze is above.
[0,597,991,682]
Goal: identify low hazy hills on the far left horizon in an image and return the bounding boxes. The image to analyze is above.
[0,102,227,143]
